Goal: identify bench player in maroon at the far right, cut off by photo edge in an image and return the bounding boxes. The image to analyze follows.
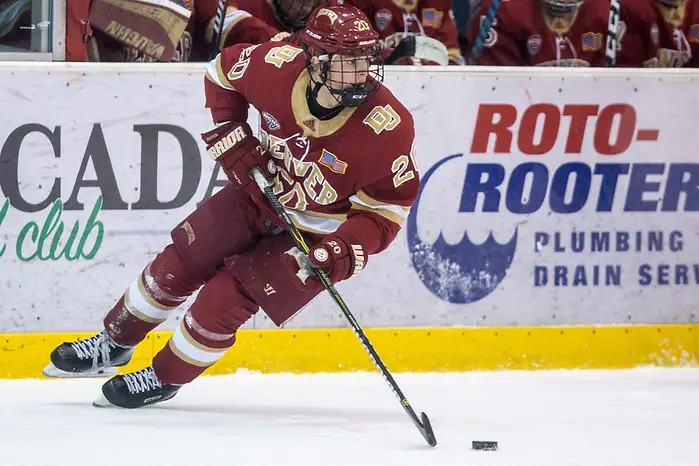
[617,0,699,68]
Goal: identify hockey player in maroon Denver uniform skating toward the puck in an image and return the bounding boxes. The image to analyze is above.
[44,5,419,408]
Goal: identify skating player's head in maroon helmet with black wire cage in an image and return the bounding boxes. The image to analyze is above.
[300,5,384,107]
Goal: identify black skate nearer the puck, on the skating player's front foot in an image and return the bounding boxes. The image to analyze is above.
[92,366,182,409]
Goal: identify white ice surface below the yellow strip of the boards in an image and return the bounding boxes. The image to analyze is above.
[0,369,699,466]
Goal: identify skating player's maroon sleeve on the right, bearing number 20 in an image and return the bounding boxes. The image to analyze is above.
[337,106,420,254]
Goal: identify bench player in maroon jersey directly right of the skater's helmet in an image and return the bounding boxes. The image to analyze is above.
[345,0,465,65]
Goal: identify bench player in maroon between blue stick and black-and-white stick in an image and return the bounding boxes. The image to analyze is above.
[468,0,609,67]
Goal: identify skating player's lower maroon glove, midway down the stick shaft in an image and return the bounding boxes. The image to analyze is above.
[282,235,367,292]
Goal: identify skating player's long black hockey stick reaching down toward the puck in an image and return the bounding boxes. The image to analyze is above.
[250,167,437,447]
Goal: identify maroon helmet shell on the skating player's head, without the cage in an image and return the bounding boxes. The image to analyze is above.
[301,5,379,53]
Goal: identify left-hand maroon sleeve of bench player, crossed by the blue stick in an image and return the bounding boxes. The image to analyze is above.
[467,1,523,66]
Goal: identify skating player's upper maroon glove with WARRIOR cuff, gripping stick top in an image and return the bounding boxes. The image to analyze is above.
[201,121,277,194]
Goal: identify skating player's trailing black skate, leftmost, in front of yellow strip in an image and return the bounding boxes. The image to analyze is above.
[43,330,135,377]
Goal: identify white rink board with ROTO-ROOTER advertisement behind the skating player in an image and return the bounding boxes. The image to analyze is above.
[0,64,699,333]
